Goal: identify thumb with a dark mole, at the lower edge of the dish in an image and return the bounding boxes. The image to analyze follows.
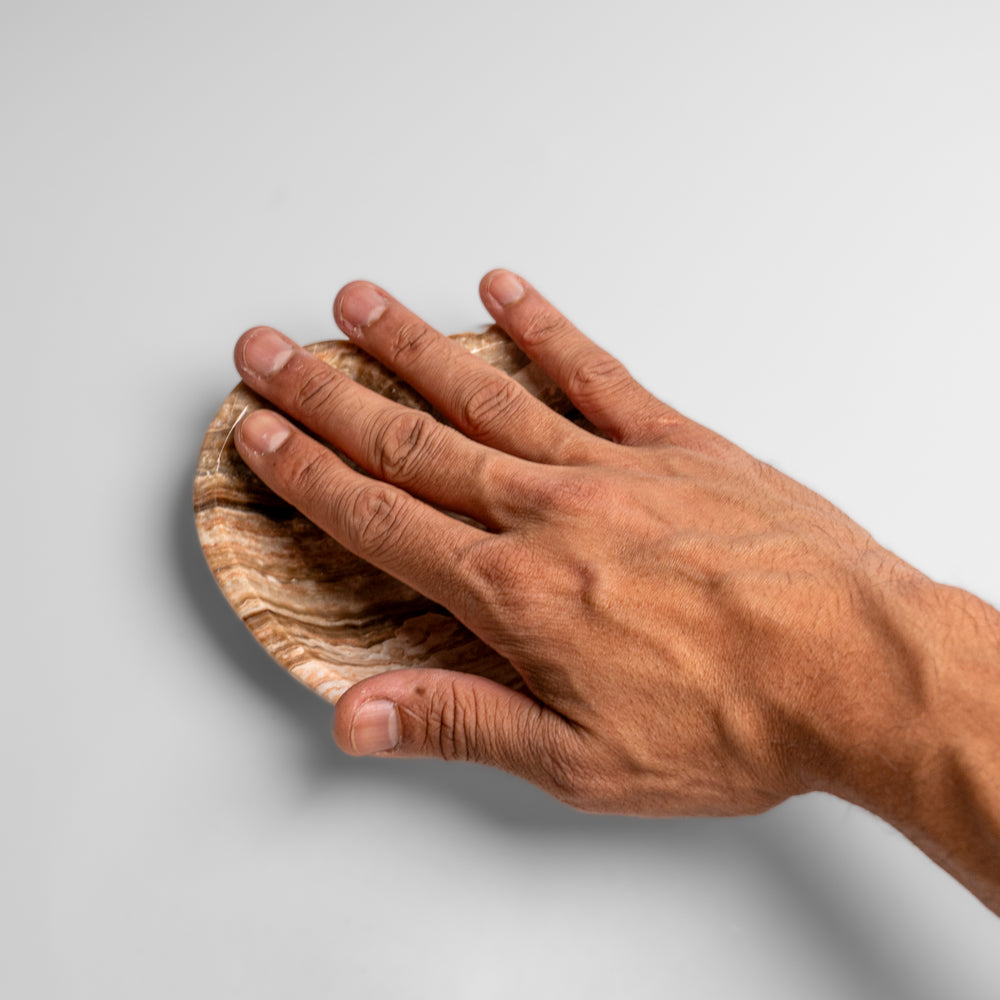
[333,669,585,798]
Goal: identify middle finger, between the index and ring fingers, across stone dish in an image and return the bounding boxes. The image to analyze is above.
[235,327,520,527]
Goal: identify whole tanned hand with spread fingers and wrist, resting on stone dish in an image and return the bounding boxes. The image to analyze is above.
[235,271,1000,913]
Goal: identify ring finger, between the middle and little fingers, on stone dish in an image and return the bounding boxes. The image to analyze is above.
[333,281,595,464]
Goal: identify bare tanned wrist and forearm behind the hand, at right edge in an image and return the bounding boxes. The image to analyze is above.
[831,581,1000,915]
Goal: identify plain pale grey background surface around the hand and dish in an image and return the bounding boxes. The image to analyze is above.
[0,0,1000,1000]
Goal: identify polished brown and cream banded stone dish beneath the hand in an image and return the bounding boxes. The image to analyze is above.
[194,327,582,703]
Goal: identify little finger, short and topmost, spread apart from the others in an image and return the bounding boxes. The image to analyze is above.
[479,270,683,444]
